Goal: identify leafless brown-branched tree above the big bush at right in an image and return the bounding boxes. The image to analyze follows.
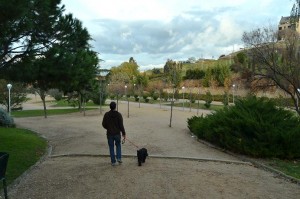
[242,27,300,115]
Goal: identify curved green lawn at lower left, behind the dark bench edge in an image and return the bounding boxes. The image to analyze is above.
[0,127,47,189]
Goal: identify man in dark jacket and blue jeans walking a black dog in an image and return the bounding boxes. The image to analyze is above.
[102,102,126,166]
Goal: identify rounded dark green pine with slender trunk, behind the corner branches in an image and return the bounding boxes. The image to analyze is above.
[5,14,99,117]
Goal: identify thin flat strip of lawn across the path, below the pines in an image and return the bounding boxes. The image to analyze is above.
[11,108,94,117]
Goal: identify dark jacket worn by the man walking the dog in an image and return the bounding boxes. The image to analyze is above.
[102,110,126,136]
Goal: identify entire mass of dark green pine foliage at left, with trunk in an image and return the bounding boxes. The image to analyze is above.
[0,0,99,116]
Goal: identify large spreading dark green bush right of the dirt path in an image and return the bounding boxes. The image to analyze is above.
[188,96,300,159]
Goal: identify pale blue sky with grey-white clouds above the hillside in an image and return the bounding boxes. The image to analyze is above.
[62,0,295,70]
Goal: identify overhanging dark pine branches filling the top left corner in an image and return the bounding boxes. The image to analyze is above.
[0,0,64,69]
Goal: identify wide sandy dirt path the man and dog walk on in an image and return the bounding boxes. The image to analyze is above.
[4,99,300,199]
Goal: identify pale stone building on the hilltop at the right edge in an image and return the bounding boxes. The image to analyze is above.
[278,17,300,40]
